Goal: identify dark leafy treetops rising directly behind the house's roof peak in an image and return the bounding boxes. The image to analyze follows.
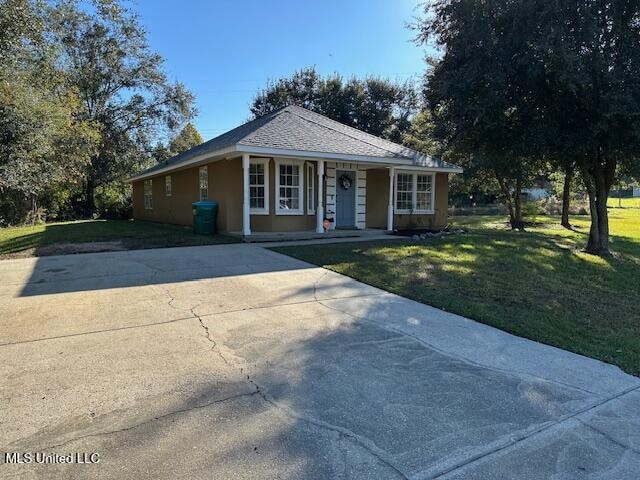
[251,68,418,142]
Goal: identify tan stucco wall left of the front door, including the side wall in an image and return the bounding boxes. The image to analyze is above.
[133,157,318,232]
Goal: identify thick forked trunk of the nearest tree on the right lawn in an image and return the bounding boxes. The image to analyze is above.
[582,150,616,257]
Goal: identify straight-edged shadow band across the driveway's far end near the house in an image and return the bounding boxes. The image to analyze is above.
[9,244,314,297]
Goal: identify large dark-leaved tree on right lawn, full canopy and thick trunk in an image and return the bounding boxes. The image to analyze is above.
[417,0,640,255]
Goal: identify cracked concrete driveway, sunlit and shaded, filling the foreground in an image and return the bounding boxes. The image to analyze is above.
[0,245,640,479]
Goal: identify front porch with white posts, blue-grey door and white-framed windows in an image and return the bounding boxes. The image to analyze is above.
[240,153,447,238]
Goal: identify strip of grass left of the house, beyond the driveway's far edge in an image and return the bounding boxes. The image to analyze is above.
[0,220,237,258]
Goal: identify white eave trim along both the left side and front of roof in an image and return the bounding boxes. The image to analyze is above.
[126,144,462,183]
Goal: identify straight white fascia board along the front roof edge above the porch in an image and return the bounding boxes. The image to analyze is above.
[236,145,462,173]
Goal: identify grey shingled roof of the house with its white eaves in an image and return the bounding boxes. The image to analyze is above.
[130,105,462,181]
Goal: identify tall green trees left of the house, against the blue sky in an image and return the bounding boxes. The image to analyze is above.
[0,0,202,224]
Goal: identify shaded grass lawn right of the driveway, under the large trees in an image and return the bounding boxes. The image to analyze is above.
[274,199,640,375]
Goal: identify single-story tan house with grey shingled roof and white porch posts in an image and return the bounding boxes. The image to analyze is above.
[129,106,462,237]
